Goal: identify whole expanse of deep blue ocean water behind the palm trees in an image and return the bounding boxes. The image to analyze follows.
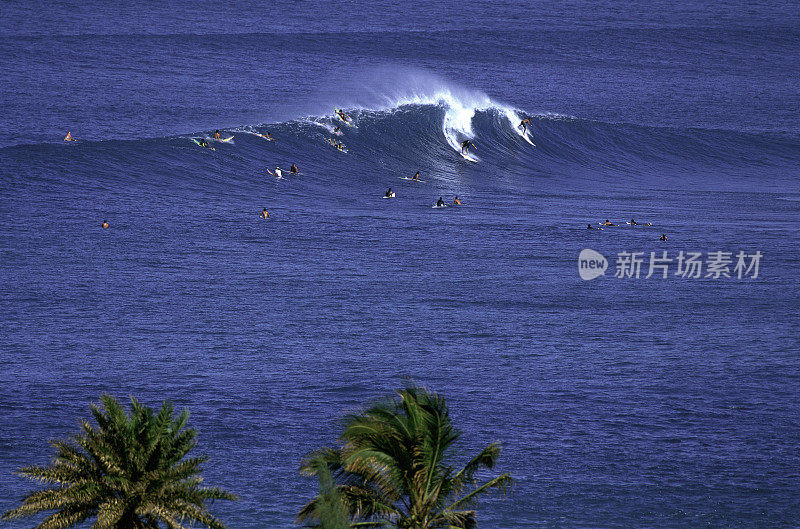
[0,1,800,528]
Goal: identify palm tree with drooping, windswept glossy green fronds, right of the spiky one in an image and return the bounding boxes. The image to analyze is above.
[298,386,512,529]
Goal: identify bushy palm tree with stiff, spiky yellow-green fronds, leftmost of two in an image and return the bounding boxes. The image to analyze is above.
[2,395,236,529]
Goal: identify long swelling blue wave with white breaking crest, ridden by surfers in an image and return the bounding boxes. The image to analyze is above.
[7,83,800,196]
